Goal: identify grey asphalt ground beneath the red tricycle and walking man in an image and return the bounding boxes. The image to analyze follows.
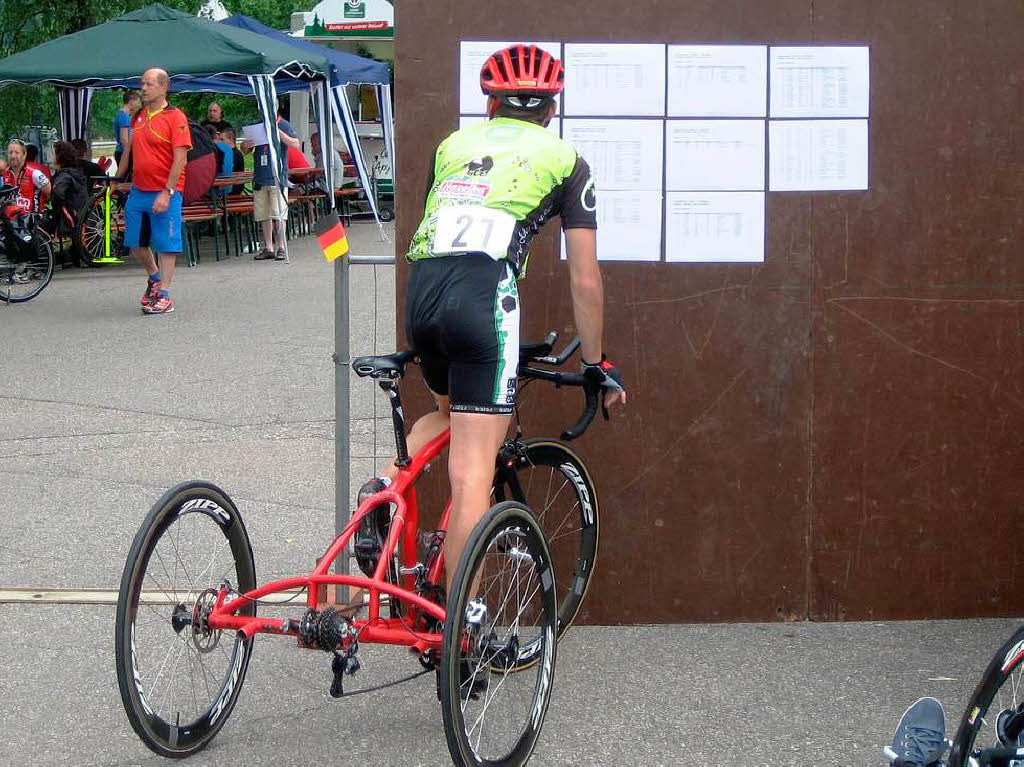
[0,224,1015,765]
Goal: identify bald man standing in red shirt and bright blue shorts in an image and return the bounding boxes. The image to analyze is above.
[118,69,191,314]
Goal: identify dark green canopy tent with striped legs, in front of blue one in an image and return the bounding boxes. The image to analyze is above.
[0,3,333,197]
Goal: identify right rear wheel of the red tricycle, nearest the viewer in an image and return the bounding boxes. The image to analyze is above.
[438,501,557,767]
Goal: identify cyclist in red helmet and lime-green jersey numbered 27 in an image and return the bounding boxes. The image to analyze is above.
[354,44,626,590]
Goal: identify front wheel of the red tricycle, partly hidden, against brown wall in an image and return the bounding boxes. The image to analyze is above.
[495,439,600,643]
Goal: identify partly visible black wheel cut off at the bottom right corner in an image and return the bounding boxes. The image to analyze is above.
[948,626,1024,767]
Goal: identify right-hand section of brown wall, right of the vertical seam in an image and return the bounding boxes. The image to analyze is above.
[806,0,1024,619]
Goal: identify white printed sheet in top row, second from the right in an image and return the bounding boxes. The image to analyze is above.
[668,45,768,117]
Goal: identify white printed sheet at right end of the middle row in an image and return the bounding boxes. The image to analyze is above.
[768,120,867,191]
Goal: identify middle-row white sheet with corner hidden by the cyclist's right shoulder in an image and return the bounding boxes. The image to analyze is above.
[562,118,665,191]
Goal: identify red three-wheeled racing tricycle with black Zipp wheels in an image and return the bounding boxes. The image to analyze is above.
[115,334,600,765]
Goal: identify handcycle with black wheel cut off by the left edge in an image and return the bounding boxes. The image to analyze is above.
[0,186,53,303]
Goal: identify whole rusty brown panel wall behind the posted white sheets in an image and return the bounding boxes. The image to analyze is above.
[395,0,1024,623]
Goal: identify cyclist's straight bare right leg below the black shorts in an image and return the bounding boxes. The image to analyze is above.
[444,413,512,593]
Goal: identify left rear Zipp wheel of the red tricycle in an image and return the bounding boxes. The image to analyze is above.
[115,482,256,757]
